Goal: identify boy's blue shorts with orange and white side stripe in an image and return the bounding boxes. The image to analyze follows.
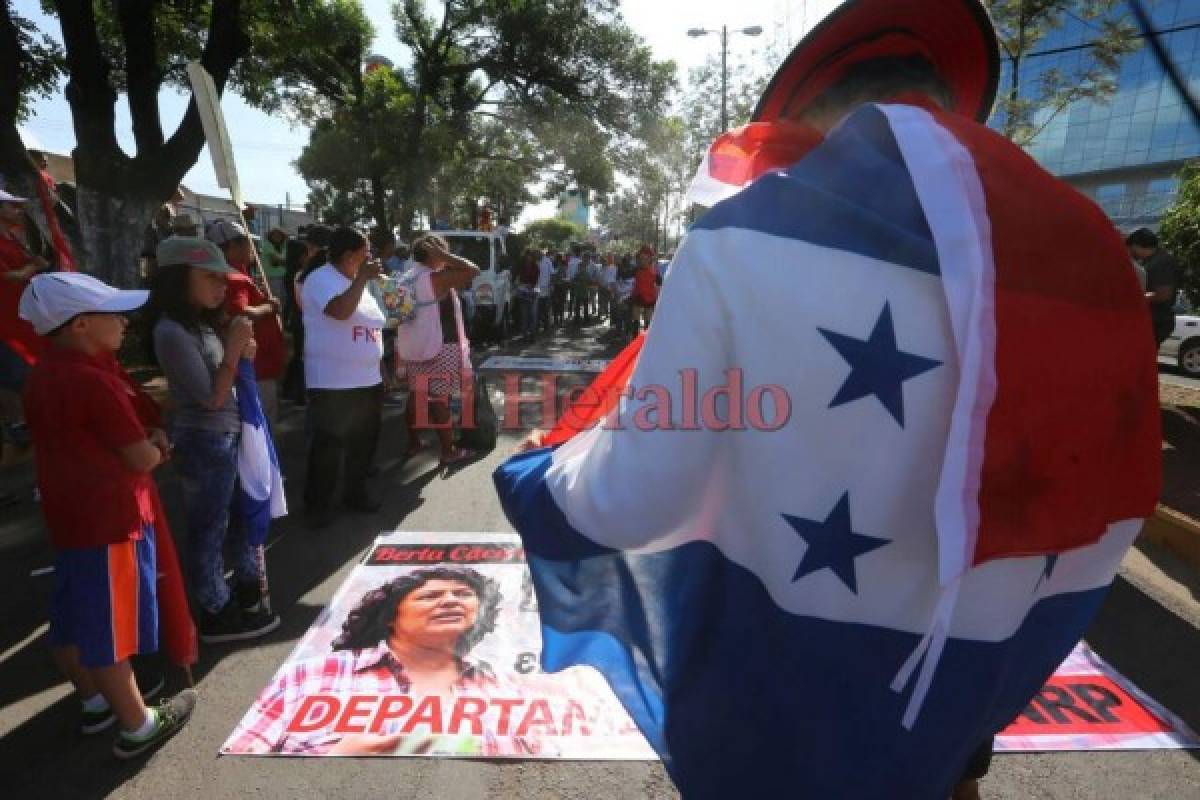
[49,525,158,667]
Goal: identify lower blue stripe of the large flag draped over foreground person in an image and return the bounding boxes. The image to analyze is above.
[494,451,1106,800]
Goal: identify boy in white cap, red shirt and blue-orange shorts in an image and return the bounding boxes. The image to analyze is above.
[19,272,196,759]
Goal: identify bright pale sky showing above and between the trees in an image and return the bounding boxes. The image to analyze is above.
[14,0,838,221]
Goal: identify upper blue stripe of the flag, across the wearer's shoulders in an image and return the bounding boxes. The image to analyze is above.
[695,106,940,275]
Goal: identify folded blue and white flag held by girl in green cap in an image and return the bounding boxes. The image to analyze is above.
[234,359,288,547]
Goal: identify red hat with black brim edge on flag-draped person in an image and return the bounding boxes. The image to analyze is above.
[752,0,1000,122]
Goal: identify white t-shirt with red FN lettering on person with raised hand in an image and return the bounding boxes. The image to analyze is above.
[300,264,385,389]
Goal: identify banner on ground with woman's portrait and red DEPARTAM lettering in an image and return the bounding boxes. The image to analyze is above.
[221,533,655,760]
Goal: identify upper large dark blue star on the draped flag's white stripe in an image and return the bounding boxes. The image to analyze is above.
[817,303,942,428]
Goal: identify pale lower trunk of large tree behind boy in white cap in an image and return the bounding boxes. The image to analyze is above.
[78,184,162,289]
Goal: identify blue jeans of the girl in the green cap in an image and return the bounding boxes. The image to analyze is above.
[174,428,258,613]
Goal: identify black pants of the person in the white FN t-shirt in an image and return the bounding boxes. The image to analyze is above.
[304,384,383,511]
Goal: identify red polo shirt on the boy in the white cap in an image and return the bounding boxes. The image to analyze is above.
[24,347,154,549]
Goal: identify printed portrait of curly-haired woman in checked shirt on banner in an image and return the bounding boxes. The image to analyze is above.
[228,567,536,756]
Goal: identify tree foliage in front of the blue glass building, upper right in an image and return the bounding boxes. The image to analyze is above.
[984,0,1141,145]
